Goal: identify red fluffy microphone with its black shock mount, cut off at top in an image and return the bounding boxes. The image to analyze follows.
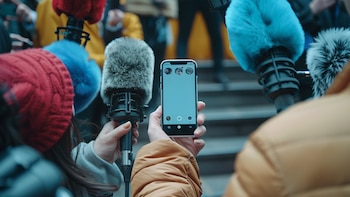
[52,0,106,47]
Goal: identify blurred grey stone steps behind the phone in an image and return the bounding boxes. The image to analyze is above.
[134,60,276,197]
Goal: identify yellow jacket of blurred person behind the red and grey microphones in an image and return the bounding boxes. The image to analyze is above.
[34,0,143,68]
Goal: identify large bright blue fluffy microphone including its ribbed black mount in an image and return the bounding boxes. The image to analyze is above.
[225,0,305,112]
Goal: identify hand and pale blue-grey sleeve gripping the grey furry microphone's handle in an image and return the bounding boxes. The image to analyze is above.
[71,121,138,186]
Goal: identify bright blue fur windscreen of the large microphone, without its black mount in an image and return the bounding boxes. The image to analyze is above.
[225,0,305,73]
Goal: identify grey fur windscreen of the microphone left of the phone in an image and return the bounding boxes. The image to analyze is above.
[101,37,154,104]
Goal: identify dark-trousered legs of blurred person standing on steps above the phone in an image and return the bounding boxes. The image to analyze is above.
[176,0,229,84]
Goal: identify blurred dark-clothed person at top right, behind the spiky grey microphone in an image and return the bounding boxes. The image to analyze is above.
[288,0,350,100]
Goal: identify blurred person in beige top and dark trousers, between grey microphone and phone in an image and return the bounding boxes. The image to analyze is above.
[125,0,178,112]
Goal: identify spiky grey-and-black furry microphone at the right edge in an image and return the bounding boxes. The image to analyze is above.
[306,28,350,97]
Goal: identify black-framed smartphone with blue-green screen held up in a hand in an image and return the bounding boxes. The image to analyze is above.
[160,59,198,137]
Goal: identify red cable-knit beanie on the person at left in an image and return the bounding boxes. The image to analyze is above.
[0,49,74,152]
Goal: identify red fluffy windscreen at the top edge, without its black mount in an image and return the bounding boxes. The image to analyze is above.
[52,0,106,24]
